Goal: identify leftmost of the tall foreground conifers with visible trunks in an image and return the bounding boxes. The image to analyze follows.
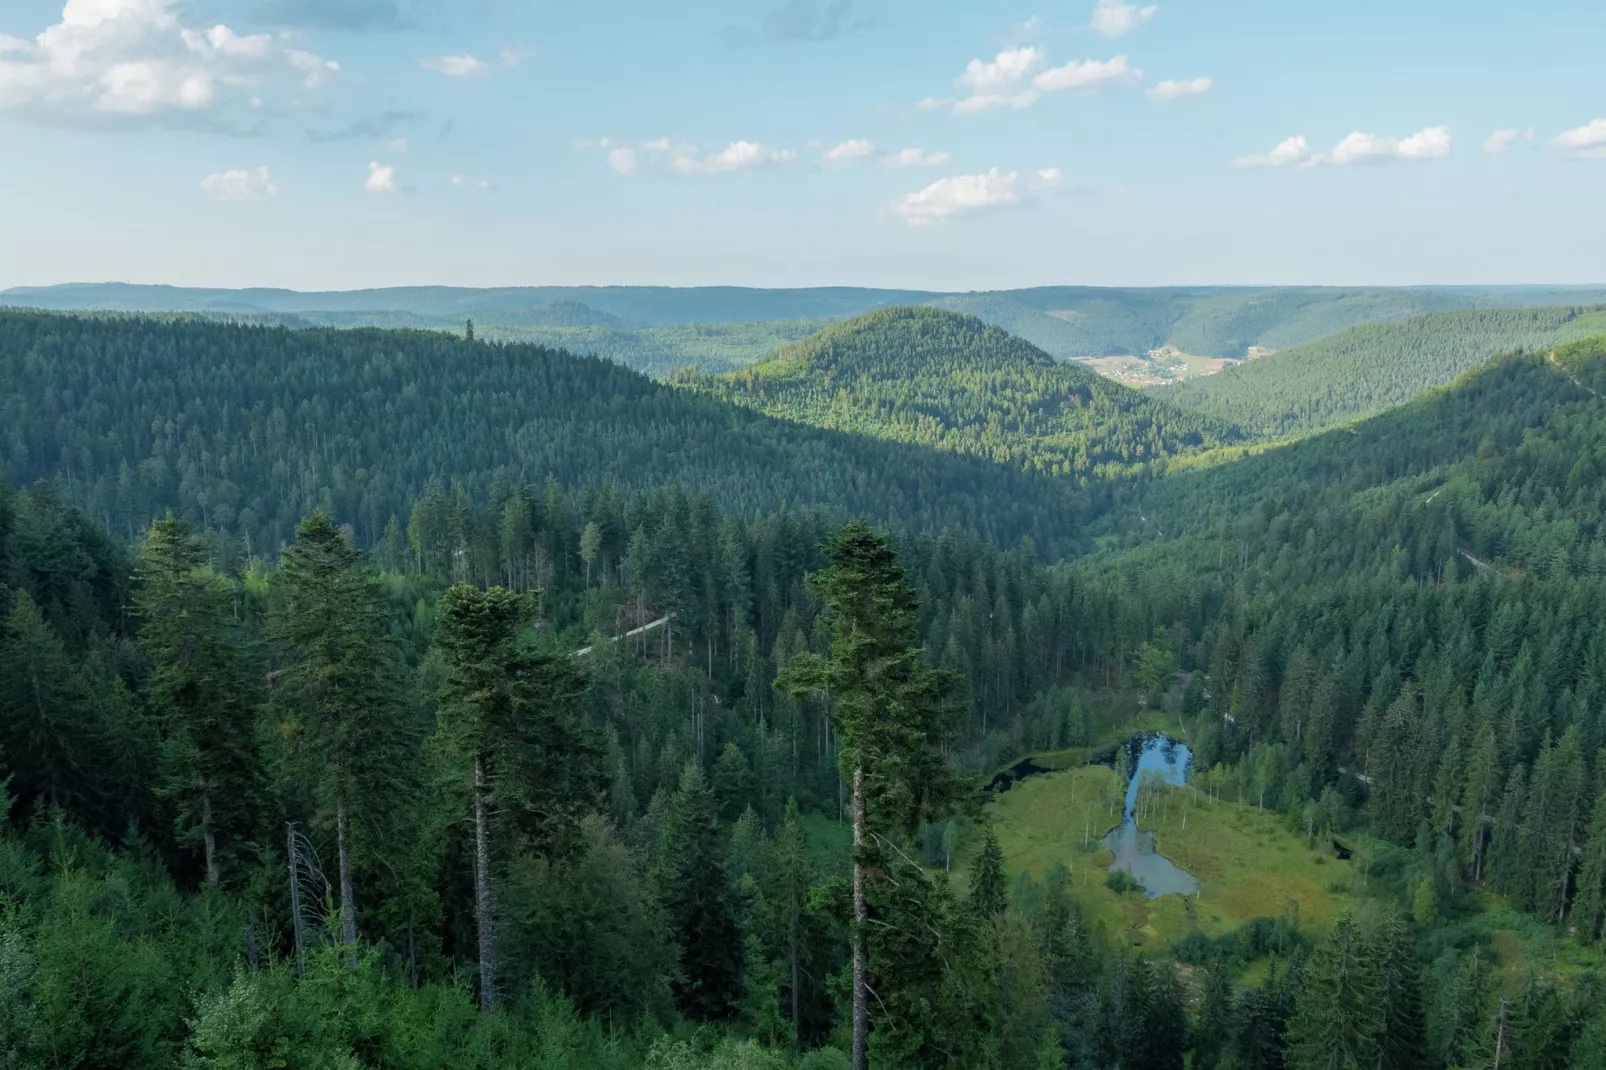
[135,516,262,884]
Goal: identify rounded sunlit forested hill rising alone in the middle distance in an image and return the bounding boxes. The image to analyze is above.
[695,308,1238,479]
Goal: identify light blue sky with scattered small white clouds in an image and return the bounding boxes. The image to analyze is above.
[0,0,1606,291]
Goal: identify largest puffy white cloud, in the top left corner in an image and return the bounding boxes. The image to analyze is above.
[0,0,339,119]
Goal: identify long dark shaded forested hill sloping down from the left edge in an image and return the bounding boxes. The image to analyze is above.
[0,312,1078,553]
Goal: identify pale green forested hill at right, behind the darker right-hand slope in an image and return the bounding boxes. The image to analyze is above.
[1150,305,1606,437]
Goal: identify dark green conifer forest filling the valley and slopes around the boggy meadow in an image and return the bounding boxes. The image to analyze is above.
[0,303,1606,1070]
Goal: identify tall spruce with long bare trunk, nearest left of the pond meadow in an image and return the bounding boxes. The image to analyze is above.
[777,521,957,1070]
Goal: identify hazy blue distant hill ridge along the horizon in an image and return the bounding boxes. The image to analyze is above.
[12,283,1606,360]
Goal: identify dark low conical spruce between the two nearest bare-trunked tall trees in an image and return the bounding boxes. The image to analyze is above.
[655,762,744,1022]
